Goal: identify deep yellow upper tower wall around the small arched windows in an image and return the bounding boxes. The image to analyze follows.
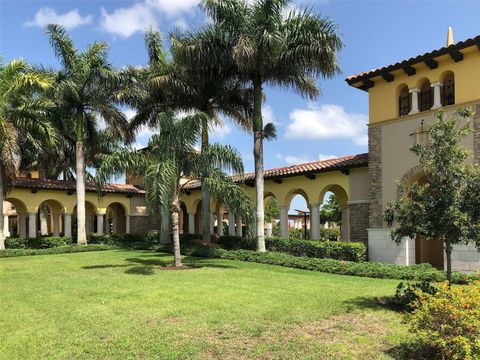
[368,46,480,124]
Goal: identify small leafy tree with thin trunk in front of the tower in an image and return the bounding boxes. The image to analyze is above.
[392,108,480,281]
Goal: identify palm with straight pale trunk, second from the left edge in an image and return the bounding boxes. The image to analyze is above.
[47,24,128,244]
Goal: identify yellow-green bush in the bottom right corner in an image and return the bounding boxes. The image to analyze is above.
[407,282,480,360]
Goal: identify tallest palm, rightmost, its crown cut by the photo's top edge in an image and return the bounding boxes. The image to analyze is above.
[191,0,343,251]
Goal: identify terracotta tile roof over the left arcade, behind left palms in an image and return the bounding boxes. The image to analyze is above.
[12,178,145,195]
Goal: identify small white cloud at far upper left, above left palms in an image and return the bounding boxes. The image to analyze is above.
[24,7,93,30]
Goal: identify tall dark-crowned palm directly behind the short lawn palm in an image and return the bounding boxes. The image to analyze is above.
[134,31,252,241]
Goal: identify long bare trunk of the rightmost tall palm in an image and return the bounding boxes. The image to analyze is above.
[253,80,266,252]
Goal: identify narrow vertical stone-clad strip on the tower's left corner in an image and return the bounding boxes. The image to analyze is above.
[368,125,383,228]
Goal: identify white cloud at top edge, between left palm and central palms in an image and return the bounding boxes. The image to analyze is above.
[100,3,158,38]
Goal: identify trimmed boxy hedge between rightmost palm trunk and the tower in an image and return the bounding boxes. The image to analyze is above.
[265,238,367,261]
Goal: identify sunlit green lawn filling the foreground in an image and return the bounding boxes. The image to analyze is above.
[0,250,406,360]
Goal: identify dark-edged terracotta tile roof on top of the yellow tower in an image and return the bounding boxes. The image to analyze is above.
[345,35,480,85]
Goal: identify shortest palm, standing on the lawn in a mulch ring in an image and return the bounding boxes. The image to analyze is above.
[97,111,252,267]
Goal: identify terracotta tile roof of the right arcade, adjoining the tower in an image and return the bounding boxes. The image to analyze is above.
[184,154,368,190]
